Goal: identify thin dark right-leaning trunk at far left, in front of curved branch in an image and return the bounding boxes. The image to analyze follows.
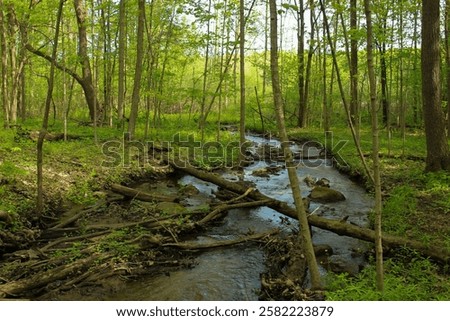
[36,0,65,217]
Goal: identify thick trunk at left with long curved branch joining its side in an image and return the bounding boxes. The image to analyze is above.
[73,0,103,121]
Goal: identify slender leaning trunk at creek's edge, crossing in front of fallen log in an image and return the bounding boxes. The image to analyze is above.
[269,0,322,289]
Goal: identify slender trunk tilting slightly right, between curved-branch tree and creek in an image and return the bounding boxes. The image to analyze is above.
[128,0,145,138]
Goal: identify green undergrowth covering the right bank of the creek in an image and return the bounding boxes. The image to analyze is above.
[291,128,450,301]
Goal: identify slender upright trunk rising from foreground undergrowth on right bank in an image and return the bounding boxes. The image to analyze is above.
[364,0,384,292]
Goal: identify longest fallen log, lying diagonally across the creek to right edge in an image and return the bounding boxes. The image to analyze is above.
[170,162,450,264]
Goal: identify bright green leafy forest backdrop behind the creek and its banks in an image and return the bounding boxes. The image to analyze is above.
[0,0,450,141]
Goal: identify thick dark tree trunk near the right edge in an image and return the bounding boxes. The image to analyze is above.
[421,0,450,171]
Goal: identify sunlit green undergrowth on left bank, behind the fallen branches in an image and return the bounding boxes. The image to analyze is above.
[0,114,243,215]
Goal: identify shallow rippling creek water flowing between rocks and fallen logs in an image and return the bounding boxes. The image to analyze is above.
[110,135,373,301]
